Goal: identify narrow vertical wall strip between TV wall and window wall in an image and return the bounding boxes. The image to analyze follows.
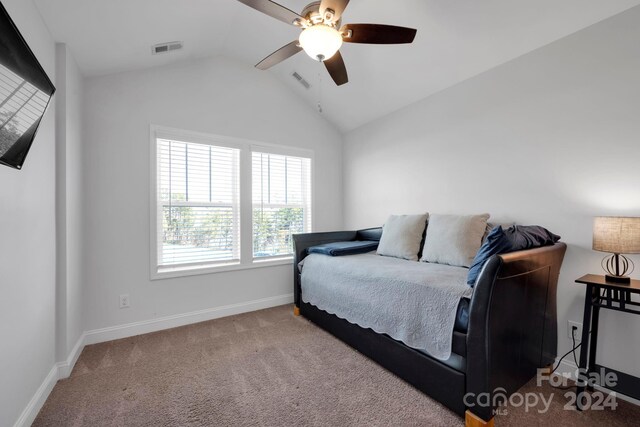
[56,43,84,361]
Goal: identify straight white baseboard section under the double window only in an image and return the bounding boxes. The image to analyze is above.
[84,294,293,345]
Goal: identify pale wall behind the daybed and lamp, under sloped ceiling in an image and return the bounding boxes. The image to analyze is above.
[344,7,640,375]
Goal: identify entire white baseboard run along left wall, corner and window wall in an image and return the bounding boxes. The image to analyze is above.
[14,294,293,427]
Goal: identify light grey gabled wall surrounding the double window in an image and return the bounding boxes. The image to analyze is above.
[83,57,342,330]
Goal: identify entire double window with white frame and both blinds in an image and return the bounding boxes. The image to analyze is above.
[151,126,312,279]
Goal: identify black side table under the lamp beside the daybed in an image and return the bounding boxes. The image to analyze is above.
[576,274,640,410]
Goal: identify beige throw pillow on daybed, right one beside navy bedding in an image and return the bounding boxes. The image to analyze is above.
[420,214,489,267]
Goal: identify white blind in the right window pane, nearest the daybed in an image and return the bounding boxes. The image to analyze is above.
[252,151,311,258]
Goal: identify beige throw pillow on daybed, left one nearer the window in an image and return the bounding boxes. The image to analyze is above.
[377,214,430,261]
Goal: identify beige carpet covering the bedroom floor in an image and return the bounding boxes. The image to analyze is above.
[34,306,640,427]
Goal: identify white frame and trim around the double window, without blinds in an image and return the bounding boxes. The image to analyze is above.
[149,124,316,280]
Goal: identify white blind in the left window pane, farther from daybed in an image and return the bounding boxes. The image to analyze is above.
[156,138,240,267]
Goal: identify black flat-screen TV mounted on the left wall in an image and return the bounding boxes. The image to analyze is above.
[0,3,56,169]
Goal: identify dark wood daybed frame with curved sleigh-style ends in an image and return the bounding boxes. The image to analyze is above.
[293,228,566,427]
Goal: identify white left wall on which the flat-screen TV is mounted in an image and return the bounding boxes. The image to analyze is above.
[0,0,56,426]
